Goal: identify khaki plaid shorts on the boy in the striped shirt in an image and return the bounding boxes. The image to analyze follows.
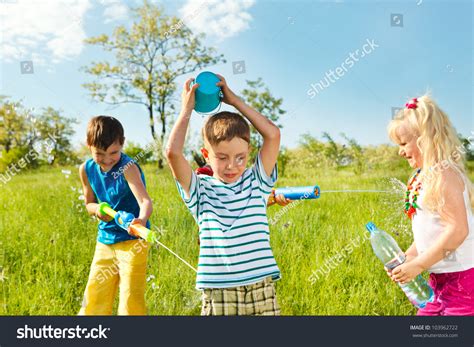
[201,277,280,316]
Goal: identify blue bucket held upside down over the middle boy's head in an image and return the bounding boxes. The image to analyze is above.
[194,71,223,113]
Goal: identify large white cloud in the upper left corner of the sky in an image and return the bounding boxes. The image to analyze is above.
[0,0,90,65]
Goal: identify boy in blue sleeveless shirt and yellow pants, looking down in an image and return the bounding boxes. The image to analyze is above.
[79,116,153,315]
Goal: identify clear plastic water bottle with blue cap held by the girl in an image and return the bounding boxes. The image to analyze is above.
[365,222,434,308]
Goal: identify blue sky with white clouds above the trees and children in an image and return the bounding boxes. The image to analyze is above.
[0,0,474,147]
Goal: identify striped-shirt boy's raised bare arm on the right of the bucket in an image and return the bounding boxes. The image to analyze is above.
[217,75,280,176]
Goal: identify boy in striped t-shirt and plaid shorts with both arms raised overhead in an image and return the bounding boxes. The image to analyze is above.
[166,75,280,315]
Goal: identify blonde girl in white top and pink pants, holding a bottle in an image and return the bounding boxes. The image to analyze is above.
[388,95,474,315]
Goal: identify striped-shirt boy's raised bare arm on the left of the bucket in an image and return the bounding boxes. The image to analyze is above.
[166,78,199,197]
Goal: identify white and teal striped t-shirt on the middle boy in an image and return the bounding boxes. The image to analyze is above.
[176,154,280,289]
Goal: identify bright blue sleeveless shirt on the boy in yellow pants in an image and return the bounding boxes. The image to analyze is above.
[85,153,150,245]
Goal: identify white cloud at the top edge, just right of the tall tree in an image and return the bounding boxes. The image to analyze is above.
[179,0,255,40]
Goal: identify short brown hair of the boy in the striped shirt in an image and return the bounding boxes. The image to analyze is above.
[202,111,250,146]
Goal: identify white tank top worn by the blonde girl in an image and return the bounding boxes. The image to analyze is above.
[412,174,474,273]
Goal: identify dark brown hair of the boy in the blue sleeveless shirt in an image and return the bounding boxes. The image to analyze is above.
[87,116,125,150]
